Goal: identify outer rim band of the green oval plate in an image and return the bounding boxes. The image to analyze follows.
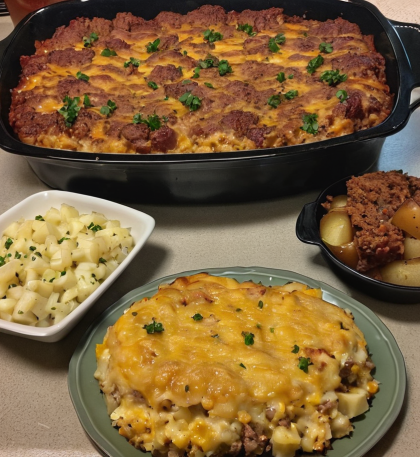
[68,266,407,457]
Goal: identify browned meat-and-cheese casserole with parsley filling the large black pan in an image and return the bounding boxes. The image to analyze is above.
[10,5,393,153]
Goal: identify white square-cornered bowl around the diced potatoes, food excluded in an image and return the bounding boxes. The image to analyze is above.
[0,190,155,342]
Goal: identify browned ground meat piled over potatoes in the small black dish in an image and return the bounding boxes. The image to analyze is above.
[347,171,420,272]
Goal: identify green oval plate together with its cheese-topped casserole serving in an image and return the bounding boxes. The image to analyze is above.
[69,267,405,457]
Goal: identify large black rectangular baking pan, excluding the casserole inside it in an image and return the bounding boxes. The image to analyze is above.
[0,0,420,203]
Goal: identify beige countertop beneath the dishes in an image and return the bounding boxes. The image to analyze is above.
[0,0,420,457]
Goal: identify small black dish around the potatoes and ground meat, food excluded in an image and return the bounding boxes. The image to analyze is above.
[296,177,420,304]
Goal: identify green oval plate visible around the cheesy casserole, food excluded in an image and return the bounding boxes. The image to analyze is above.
[68,267,406,457]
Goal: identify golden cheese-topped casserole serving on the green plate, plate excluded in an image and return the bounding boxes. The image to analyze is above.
[95,273,377,457]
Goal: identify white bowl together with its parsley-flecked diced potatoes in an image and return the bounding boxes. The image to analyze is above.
[0,191,155,342]
